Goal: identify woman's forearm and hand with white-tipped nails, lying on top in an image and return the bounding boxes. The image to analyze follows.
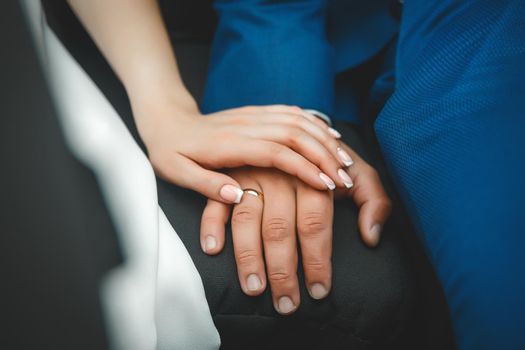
[68,0,354,203]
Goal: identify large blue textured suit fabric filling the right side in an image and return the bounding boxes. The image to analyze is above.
[375,0,525,350]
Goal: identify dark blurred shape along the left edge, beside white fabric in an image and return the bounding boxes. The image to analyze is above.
[0,1,121,350]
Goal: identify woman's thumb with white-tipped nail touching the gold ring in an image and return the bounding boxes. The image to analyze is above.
[154,154,244,204]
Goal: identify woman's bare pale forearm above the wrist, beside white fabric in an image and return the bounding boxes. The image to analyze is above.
[68,0,197,114]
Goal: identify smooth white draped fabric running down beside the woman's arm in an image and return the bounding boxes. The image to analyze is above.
[21,0,220,350]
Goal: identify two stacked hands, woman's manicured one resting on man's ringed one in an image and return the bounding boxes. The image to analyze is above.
[137,100,390,315]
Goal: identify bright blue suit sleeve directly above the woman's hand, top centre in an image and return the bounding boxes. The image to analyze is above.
[201,0,334,114]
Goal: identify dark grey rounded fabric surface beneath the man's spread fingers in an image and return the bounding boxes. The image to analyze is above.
[158,122,412,348]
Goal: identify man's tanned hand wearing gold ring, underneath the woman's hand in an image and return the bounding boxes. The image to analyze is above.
[201,145,390,314]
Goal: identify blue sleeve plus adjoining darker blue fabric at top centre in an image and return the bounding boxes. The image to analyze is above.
[201,0,398,122]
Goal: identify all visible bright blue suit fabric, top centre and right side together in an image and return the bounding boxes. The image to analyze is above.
[202,0,525,350]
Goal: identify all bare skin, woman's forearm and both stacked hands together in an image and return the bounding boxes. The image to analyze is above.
[68,0,390,314]
